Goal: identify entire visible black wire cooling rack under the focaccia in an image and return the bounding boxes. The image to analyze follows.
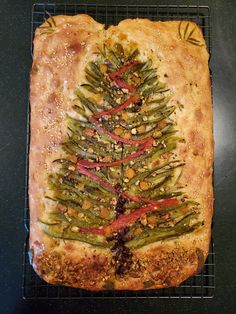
[22,3,215,299]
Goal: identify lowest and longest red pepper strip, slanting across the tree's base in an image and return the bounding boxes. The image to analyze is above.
[80,199,178,235]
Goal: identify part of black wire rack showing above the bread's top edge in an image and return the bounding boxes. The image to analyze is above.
[32,3,212,53]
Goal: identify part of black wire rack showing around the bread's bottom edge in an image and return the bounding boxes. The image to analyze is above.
[23,241,215,299]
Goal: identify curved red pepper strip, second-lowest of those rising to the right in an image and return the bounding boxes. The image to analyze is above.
[77,138,153,168]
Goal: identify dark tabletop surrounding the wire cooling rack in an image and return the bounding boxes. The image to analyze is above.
[0,0,236,314]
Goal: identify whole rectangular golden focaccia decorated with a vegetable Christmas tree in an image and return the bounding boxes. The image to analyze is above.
[29,15,213,290]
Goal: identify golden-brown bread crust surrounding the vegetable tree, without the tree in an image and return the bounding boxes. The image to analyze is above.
[29,15,213,290]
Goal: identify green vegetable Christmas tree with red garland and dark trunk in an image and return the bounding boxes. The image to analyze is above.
[40,44,201,275]
